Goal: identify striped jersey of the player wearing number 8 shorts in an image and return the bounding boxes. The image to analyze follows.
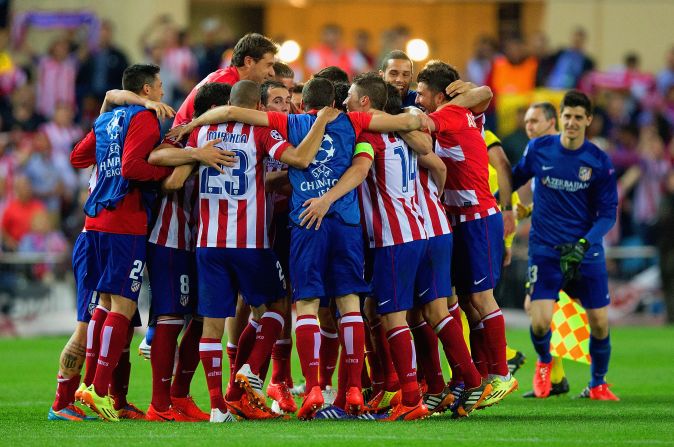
[148,133,198,251]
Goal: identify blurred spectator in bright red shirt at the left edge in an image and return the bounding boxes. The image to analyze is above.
[0,175,45,251]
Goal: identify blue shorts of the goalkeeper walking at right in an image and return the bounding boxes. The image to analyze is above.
[528,256,611,309]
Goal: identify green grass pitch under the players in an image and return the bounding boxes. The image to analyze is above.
[0,327,674,447]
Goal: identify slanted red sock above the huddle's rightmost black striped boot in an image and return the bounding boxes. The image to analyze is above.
[435,315,482,388]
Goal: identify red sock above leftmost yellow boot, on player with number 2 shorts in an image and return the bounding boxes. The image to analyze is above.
[93,312,131,396]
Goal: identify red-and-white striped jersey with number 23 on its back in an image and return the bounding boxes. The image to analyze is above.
[188,123,290,248]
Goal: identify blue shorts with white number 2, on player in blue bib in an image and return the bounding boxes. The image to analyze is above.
[84,231,147,301]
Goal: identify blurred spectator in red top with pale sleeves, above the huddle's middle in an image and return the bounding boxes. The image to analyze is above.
[305,24,367,77]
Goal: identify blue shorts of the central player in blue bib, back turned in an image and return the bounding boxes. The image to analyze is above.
[290,217,370,301]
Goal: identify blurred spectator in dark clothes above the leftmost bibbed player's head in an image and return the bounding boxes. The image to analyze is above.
[77,20,129,104]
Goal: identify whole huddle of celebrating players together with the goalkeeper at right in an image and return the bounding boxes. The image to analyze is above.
[49,34,617,422]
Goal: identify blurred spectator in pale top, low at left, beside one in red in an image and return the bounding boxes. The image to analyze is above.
[17,210,68,280]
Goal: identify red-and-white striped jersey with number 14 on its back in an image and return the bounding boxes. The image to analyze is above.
[358,132,427,247]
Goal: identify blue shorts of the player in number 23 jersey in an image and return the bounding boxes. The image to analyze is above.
[197,248,286,318]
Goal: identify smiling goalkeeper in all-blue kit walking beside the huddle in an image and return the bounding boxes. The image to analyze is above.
[513,91,618,400]
